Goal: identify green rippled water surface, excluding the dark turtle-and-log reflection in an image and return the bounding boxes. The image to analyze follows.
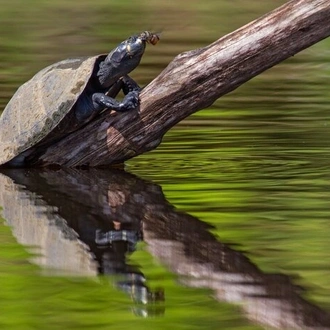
[0,0,330,329]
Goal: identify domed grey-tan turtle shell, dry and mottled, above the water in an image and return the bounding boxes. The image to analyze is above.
[0,56,101,165]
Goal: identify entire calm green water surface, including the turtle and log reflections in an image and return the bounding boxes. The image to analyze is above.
[0,0,330,330]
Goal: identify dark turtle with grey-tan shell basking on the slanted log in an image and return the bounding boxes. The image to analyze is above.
[0,31,159,167]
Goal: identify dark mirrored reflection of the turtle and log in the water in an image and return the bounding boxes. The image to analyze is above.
[0,169,330,329]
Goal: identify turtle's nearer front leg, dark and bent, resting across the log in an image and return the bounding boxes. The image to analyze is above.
[92,91,140,112]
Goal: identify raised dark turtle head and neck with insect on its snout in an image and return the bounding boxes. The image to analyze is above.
[97,31,159,87]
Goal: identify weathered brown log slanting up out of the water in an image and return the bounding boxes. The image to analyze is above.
[40,0,330,167]
